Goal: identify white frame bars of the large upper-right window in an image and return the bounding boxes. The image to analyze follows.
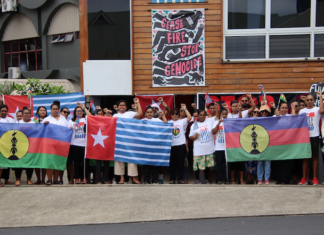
[222,0,324,63]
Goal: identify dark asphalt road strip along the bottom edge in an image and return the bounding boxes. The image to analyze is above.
[0,215,324,235]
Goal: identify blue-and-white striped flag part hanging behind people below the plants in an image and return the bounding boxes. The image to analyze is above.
[33,92,85,115]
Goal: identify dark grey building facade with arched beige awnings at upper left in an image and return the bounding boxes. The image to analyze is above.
[0,0,80,84]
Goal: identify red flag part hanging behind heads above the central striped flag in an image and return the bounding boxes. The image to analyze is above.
[135,94,174,113]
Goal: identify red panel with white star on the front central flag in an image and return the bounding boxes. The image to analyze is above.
[86,116,117,161]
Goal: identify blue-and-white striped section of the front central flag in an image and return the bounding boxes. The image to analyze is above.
[115,118,173,166]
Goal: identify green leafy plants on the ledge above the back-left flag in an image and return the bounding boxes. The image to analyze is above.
[14,78,70,95]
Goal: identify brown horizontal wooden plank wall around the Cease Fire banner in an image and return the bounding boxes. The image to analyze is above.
[133,0,324,94]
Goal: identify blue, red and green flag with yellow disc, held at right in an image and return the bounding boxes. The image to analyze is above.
[224,114,311,162]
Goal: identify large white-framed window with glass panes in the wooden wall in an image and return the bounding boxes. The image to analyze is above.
[223,0,324,61]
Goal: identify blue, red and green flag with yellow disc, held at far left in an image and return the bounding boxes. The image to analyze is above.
[0,123,73,170]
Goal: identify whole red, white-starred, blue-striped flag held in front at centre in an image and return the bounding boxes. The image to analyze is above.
[86,116,173,166]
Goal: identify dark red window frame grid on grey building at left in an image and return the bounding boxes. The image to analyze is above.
[2,37,43,73]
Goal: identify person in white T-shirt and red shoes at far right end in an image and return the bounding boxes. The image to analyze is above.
[299,92,324,185]
